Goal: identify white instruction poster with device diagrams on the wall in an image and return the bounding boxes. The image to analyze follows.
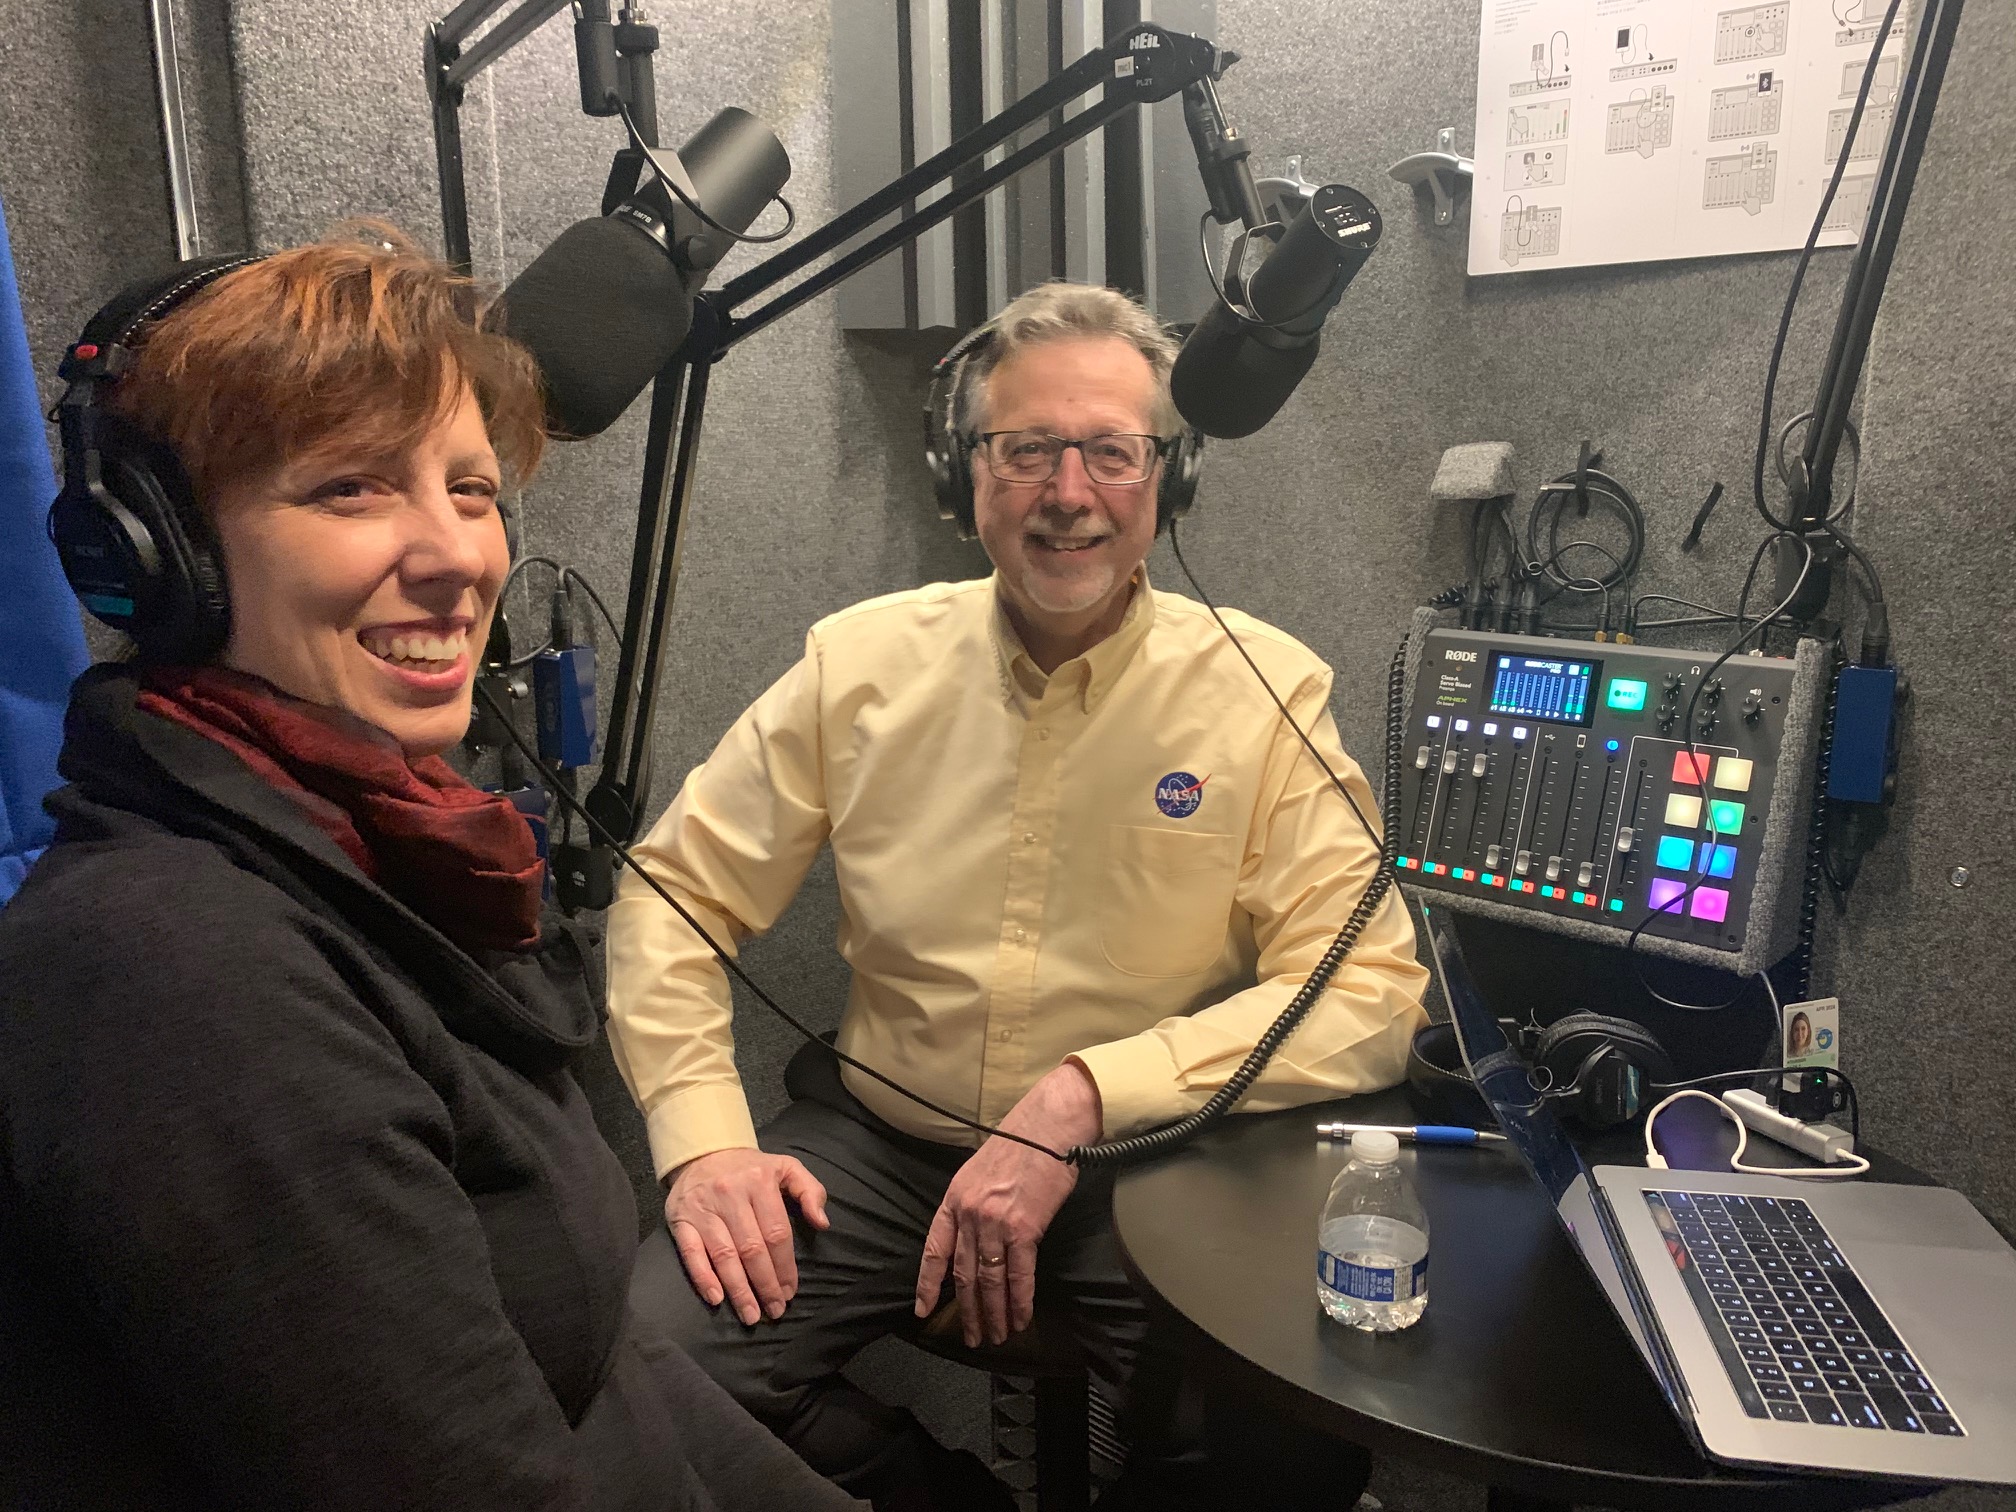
[1470,0,1905,274]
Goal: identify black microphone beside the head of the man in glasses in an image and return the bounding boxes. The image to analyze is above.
[1169,183,1379,439]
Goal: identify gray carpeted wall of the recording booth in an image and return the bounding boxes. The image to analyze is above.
[0,0,2016,1499]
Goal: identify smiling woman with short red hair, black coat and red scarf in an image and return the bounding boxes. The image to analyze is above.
[0,228,855,1512]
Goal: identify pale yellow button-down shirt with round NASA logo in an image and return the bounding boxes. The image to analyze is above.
[609,579,1427,1173]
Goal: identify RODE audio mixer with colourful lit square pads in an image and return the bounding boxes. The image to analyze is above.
[1395,629,1812,971]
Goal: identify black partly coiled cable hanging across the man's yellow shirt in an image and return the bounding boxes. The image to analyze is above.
[472,520,1407,1169]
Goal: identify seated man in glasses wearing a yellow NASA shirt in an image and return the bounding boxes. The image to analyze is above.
[609,284,1425,1510]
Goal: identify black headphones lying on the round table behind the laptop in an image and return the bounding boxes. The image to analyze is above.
[1407,1014,1677,1129]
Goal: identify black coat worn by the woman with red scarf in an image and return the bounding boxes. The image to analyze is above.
[0,667,849,1512]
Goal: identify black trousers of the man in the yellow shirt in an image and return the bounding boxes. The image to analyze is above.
[631,1054,1371,1512]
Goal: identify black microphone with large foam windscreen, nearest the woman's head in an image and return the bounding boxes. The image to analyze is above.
[492,107,790,439]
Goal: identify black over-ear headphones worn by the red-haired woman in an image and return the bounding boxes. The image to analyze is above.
[48,254,260,663]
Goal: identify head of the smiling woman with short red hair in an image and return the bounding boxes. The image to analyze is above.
[111,224,544,756]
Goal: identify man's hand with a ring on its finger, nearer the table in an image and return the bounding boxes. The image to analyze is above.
[917,1060,1101,1349]
